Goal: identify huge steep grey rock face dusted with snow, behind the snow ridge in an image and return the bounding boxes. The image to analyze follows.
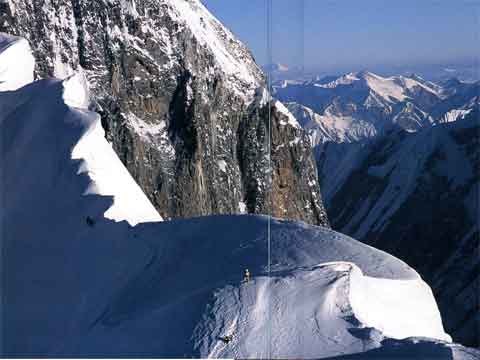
[0,0,327,224]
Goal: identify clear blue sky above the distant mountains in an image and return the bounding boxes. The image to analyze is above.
[203,0,480,71]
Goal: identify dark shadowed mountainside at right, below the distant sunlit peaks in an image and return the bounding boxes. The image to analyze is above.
[319,114,480,346]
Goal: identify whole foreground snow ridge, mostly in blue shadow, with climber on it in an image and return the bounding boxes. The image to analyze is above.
[0,36,480,360]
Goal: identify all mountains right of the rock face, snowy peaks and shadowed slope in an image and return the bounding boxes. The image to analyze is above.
[275,72,480,346]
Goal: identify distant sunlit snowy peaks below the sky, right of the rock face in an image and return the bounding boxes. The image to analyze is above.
[275,71,444,145]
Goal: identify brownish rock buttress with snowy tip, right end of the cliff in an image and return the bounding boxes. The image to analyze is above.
[238,102,328,224]
